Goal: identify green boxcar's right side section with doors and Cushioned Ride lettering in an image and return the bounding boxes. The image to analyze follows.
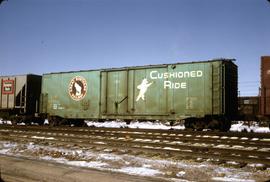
[101,61,228,120]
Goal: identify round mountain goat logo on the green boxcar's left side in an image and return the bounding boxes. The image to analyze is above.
[68,76,87,101]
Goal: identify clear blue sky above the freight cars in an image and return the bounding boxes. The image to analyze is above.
[0,0,270,96]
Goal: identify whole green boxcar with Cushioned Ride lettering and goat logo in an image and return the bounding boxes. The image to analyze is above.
[40,59,237,131]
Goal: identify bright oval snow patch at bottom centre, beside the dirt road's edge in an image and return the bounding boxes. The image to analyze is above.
[118,167,162,176]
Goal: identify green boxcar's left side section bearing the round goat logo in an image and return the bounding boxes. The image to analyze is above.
[42,71,100,119]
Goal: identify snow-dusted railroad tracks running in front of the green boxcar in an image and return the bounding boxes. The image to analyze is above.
[0,125,270,166]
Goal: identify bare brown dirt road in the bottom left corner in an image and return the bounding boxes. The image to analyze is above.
[0,155,161,182]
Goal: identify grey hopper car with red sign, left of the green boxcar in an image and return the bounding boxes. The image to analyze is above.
[0,74,42,122]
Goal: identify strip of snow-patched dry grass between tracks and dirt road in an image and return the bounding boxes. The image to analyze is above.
[0,141,270,182]
